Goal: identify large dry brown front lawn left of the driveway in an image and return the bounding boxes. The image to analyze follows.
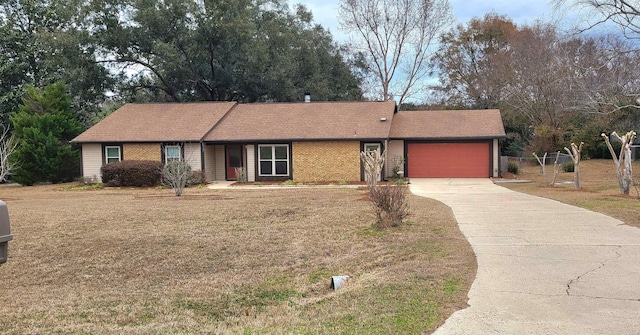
[0,186,476,334]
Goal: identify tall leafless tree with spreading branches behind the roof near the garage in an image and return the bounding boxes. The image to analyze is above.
[339,0,452,105]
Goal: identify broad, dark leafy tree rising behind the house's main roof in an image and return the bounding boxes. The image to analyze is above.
[87,0,362,102]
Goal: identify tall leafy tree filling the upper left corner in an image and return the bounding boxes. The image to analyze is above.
[0,0,114,125]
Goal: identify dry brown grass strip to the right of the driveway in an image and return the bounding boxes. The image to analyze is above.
[500,159,640,227]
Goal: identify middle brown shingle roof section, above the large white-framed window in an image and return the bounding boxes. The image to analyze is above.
[205,101,395,141]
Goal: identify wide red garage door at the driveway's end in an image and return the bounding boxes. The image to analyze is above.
[407,142,490,178]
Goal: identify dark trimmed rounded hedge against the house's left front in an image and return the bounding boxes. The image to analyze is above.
[100,160,162,187]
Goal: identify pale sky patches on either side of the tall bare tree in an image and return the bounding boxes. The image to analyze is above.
[298,0,553,40]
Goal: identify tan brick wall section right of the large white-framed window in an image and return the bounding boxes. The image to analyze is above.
[291,142,361,182]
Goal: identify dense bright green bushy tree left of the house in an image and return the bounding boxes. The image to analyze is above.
[9,83,85,185]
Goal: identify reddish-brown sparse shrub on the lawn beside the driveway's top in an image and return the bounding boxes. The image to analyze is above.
[369,185,409,229]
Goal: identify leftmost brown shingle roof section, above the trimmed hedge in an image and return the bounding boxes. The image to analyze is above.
[72,102,235,142]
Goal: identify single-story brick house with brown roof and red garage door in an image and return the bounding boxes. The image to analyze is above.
[72,101,505,182]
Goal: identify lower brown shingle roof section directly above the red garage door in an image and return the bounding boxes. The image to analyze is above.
[389,109,505,139]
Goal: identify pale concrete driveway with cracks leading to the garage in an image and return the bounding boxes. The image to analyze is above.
[410,178,640,335]
